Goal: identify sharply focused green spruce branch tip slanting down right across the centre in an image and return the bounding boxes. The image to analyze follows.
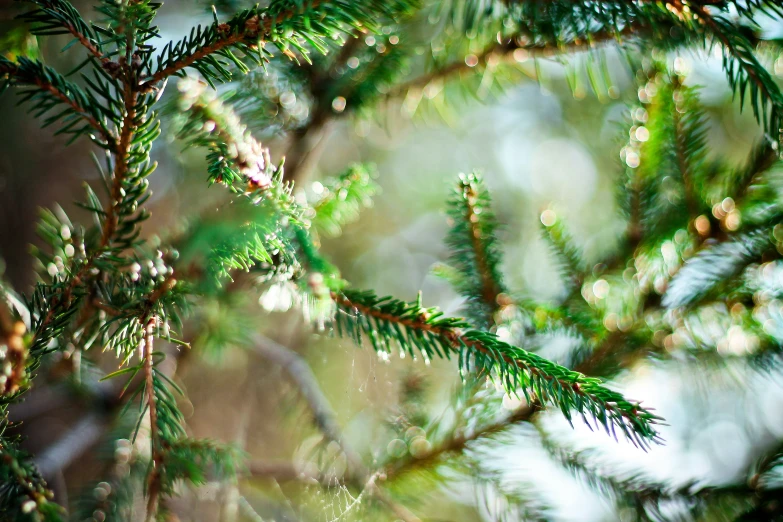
[332,292,660,442]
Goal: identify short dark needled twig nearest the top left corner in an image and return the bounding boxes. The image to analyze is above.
[20,0,111,64]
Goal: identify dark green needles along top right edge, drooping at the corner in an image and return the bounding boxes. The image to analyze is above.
[444,0,783,139]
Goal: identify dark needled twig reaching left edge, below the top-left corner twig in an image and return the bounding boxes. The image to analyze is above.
[0,56,115,150]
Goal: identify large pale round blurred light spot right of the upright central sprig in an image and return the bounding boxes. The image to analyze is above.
[530,138,598,206]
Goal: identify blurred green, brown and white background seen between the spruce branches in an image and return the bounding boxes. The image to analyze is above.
[0,0,783,522]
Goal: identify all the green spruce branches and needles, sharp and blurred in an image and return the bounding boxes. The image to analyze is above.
[0,0,783,520]
